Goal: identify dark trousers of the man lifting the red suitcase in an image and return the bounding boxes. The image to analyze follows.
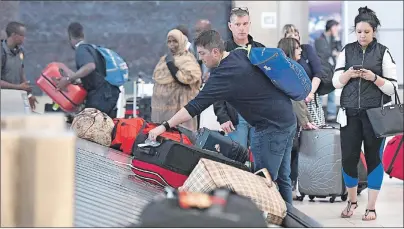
[85,82,120,118]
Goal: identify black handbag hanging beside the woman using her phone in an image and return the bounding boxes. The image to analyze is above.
[366,86,404,138]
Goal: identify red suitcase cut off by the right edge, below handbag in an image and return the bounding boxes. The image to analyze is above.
[383,135,404,180]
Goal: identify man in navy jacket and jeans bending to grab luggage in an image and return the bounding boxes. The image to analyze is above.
[149,30,296,203]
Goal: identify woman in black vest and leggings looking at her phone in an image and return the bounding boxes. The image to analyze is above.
[333,7,397,220]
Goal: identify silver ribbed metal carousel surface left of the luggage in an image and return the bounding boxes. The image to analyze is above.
[75,139,162,227]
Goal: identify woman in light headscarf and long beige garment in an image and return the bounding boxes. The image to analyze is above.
[152,29,202,131]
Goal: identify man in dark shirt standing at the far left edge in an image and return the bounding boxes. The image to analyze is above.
[0,21,38,110]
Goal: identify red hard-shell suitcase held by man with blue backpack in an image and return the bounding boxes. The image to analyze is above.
[36,62,87,112]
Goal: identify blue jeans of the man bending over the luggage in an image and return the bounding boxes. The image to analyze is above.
[251,123,296,204]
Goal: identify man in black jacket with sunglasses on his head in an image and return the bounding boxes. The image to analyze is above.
[213,7,264,147]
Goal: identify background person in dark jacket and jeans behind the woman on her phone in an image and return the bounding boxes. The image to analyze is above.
[314,20,342,122]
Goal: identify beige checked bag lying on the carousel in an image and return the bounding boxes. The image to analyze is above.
[178,158,287,225]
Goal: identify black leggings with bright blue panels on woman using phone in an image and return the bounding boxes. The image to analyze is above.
[341,109,384,190]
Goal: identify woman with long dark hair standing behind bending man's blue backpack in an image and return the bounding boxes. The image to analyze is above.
[278,36,318,200]
